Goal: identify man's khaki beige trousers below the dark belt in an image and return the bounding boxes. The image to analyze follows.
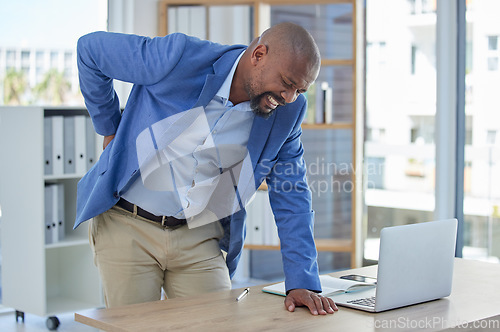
[89,206,231,308]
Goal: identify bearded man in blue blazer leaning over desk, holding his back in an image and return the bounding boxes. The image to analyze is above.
[75,23,337,315]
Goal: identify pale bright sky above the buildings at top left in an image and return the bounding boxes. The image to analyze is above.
[0,0,107,48]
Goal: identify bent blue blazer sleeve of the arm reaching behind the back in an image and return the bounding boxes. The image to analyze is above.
[77,31,186,135]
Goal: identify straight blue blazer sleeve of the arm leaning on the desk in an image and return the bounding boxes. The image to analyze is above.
[266,96,321,292]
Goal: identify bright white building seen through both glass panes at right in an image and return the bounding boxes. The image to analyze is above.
[364,0,500,262]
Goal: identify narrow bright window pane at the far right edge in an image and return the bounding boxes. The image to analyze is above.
[463,1,500,262]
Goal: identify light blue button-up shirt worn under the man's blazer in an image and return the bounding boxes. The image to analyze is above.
[122,55,255,218]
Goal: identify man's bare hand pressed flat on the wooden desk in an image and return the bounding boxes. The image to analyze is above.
[285,289,339,315]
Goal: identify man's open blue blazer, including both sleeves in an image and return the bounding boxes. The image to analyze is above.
[74,32,321,291]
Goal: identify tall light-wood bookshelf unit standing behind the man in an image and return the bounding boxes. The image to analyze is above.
[158,0,364,268]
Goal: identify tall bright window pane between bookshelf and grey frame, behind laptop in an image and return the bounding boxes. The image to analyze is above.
[364,0,436,263]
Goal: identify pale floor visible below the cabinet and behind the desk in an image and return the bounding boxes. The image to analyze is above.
[0,280,265,332]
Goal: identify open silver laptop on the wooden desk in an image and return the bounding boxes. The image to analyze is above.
[330,219,458,312]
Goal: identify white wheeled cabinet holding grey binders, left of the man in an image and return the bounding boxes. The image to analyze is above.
[0,107,103,326]
